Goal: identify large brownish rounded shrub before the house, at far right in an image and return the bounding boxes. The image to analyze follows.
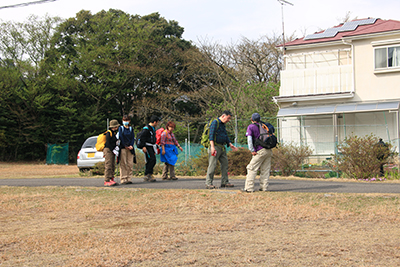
[332,134,394,179]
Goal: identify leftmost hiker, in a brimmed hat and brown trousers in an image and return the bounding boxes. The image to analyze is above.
[103,120,120,186]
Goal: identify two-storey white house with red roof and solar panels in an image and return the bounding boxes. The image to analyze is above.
[274,18,400,161]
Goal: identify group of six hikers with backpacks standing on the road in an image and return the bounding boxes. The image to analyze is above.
[103,110,276,193]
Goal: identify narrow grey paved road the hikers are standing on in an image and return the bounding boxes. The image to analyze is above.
[0,178,400,194]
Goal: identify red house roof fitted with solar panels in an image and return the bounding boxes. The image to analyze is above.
[285,18,400,47]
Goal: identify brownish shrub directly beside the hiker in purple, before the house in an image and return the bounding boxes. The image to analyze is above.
[272,143,312,176]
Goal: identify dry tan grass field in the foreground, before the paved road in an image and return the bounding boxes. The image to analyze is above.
[0,162,400,266]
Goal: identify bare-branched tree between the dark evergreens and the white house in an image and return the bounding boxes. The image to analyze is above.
[194,35,284,116]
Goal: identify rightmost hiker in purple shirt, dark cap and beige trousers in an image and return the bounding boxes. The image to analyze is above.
[243,113,275,193]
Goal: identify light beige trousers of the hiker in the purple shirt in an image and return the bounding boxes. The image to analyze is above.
[244,148,272,191]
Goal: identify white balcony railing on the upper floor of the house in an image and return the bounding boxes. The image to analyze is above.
[280,65,353,96]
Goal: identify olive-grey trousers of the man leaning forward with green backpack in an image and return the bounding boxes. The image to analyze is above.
[206,145,229,185]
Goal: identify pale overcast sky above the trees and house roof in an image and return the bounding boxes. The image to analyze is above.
[0,0,400,44]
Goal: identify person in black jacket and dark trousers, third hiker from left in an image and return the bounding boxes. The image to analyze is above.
[141,115,160,182]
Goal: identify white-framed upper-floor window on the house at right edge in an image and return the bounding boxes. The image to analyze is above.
[375,46,400,69]
